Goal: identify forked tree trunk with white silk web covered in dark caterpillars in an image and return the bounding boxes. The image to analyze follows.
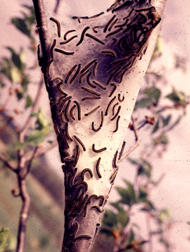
[33,0,166,252]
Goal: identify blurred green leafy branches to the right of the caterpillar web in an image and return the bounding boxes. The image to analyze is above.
[100,37,189,252]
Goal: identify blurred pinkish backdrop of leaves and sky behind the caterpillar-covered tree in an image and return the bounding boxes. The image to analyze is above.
[0,0,190,252]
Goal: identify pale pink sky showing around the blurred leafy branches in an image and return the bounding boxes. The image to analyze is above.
[0,0,190,252]
